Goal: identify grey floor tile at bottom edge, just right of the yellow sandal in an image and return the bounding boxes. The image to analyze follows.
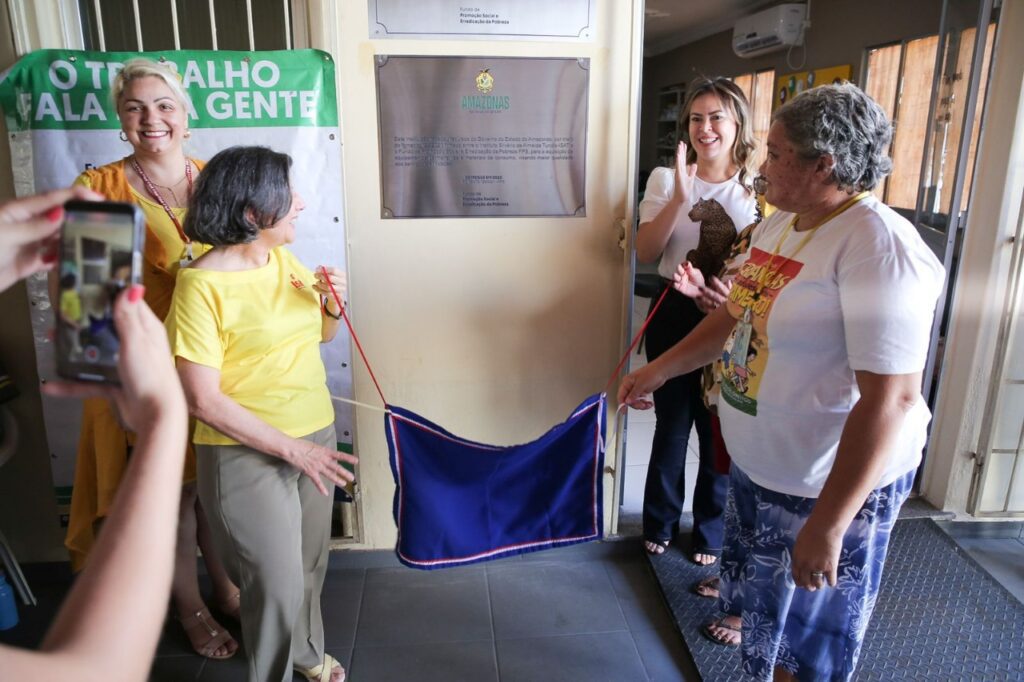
[348,641,497,682]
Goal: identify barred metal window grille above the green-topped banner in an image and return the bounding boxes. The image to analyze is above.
[77,0,304,52]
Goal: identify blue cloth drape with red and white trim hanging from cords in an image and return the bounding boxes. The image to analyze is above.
[385,393,605,569]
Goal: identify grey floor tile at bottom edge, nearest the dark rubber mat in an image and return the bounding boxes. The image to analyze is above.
[495,632,647,682]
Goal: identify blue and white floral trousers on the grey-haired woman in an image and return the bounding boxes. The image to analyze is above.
[720,463,914,681]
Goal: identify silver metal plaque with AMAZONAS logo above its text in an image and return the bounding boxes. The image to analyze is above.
[377,55,590,218]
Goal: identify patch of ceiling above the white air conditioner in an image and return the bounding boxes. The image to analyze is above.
[643,0,777,56]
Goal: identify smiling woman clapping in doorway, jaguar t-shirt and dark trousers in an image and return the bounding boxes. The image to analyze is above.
[636,73,757,565]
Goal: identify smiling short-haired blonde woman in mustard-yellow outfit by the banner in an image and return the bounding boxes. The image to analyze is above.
[65,59,239,658]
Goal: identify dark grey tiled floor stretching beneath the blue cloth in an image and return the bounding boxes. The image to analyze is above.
[0,538,699,682]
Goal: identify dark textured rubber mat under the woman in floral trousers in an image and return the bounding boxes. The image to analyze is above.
[650,518,1024,682]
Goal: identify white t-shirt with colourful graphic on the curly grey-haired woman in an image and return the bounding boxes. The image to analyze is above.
[716,196,944,498]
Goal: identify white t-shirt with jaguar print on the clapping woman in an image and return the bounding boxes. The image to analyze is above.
[640,167,757,280]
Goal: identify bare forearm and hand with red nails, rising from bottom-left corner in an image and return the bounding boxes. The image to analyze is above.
[0,287,188,682]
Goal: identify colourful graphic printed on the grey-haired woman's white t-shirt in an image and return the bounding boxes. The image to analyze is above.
[715,248,804,416]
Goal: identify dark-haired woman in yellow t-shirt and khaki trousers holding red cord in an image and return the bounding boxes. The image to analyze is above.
[167,146,356,682]
